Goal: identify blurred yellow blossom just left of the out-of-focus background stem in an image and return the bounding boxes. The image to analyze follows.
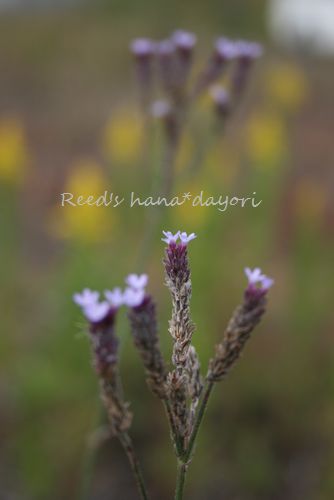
[102,108,143,164]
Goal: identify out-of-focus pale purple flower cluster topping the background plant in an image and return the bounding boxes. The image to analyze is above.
[130,30,262,121]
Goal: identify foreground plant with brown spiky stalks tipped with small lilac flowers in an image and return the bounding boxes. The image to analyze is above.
[73,231,273,499]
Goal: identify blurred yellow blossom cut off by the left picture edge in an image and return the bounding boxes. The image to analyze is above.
[0,117,29,184]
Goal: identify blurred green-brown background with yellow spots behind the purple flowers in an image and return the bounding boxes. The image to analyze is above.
[0,0,334,500]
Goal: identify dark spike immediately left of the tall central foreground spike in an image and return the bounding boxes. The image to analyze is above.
[129,295,166,399]
